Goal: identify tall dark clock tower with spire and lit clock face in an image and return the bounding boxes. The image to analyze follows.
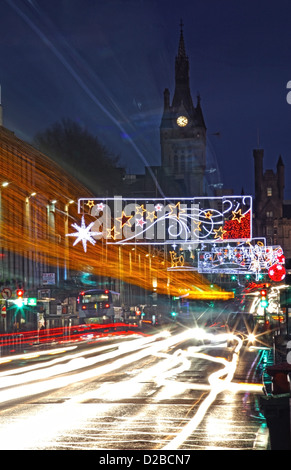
[160,23,206,197]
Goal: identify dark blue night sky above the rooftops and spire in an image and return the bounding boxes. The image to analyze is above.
[0,0,291,199]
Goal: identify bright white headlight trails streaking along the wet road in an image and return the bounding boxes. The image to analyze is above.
[0,330,262,450]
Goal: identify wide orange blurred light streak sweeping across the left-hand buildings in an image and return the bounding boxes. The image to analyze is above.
[0,125,233,300]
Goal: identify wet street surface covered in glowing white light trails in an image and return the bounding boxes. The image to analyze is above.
[0,329,268,451]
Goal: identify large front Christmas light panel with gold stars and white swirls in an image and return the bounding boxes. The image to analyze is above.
[78,196,252,245]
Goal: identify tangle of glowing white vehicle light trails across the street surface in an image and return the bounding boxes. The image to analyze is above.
[0,329,261,450]
